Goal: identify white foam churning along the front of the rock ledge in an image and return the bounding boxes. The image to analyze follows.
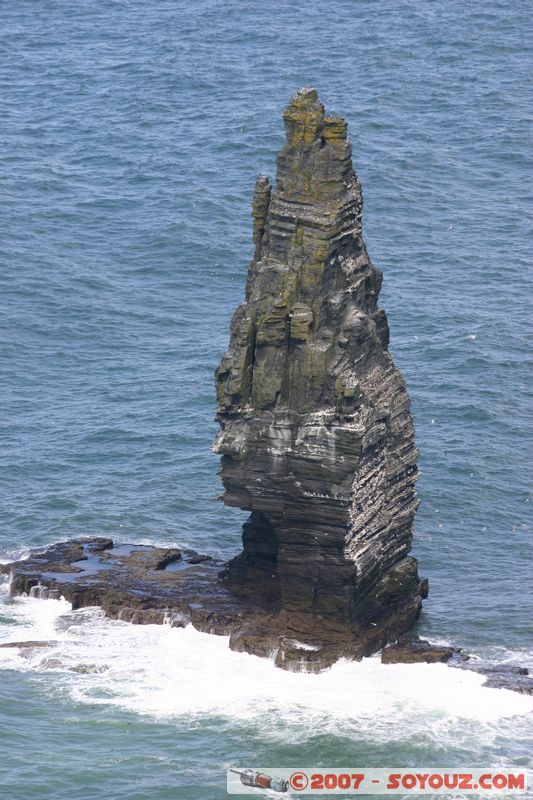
[0,584,533,740]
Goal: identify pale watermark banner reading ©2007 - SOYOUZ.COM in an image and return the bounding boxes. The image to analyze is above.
[227,767,528,797]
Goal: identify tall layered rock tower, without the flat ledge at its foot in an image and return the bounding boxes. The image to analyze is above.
[214,89,427,636]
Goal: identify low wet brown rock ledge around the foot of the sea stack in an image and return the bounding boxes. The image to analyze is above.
[0,537,420,672]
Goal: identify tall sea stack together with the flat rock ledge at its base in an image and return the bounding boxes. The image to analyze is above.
[0,89,427,671]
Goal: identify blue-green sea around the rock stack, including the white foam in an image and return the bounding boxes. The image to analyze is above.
[0,0,533,800]
